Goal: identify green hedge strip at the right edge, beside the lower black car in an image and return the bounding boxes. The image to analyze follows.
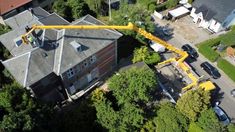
[217,58,235,82]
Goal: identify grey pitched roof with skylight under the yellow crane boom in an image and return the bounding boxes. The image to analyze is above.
[0,8,122,86]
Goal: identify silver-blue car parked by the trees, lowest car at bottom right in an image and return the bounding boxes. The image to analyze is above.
[213,105,230,125]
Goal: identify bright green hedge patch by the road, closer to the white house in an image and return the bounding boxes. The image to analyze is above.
[198,38,220,62]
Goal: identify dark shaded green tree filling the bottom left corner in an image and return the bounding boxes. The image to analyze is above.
[0,82,51,131]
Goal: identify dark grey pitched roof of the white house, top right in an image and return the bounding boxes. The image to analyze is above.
[192,0,235,22]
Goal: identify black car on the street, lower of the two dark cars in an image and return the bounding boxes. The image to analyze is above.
[201,62,221,79]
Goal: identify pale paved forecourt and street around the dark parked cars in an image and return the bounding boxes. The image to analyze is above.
[155,16,235,123]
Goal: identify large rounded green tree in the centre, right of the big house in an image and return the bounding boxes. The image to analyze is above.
[108,67,157,104]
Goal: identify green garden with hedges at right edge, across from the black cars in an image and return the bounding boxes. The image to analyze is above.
[197,26,235,82]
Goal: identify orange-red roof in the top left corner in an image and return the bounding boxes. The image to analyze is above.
[0,0,32,15]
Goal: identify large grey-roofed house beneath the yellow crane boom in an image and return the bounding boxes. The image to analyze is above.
[0,7,122,102]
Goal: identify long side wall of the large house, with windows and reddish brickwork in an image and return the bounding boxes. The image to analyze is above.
[62,41,117,94]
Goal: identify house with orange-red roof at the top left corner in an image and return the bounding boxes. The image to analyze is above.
[0,0,54,24]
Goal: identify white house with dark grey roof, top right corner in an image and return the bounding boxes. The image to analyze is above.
[190,0,235,33]
